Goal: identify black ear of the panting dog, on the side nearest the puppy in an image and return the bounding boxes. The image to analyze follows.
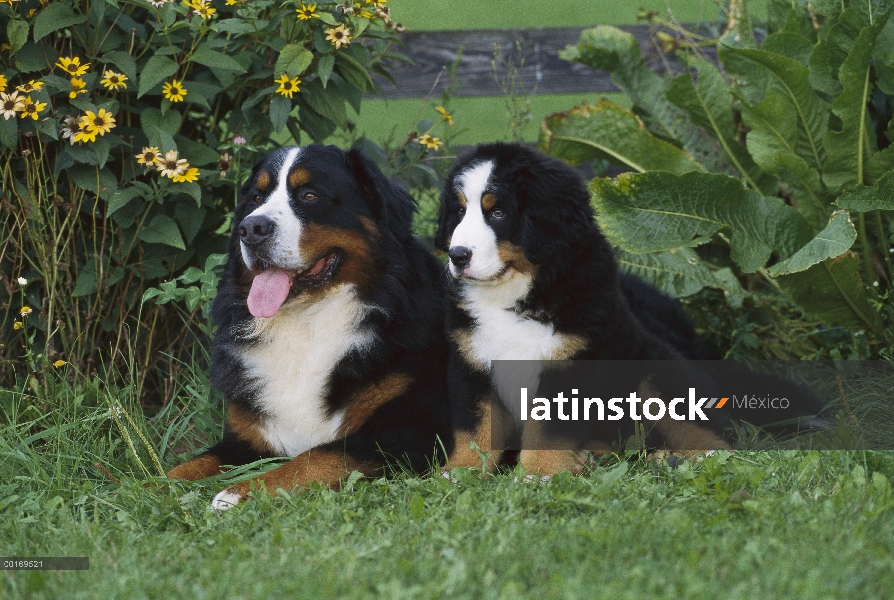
[345,148,416,237]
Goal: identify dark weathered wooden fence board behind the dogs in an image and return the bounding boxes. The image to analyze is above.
[377,25,714,98]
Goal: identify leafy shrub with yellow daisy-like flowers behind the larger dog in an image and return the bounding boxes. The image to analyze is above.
[0,0,406,390]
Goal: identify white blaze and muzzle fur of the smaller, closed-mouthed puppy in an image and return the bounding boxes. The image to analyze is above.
[450,160,503,279]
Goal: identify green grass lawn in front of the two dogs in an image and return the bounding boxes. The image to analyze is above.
[0,370,894,599]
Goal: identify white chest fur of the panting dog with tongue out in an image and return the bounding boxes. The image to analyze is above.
[236,285,372,456]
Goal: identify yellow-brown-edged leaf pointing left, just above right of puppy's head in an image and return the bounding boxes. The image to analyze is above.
[539,101,704,173]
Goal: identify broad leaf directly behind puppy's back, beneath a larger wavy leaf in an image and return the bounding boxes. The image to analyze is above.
[615,247,749,308]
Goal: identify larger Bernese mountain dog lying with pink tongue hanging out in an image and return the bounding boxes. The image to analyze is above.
[168,145,451,509]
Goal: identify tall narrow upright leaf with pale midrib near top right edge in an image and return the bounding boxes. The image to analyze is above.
[823,13,888,192]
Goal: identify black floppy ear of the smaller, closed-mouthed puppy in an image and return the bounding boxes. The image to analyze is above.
[518,157,596,265]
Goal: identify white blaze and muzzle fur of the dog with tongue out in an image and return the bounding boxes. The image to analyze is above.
[239,148,309,270]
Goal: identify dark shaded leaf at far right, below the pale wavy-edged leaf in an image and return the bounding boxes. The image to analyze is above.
[776,251,881,333]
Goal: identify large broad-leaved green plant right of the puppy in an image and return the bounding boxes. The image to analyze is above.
[540,0,894,350]
